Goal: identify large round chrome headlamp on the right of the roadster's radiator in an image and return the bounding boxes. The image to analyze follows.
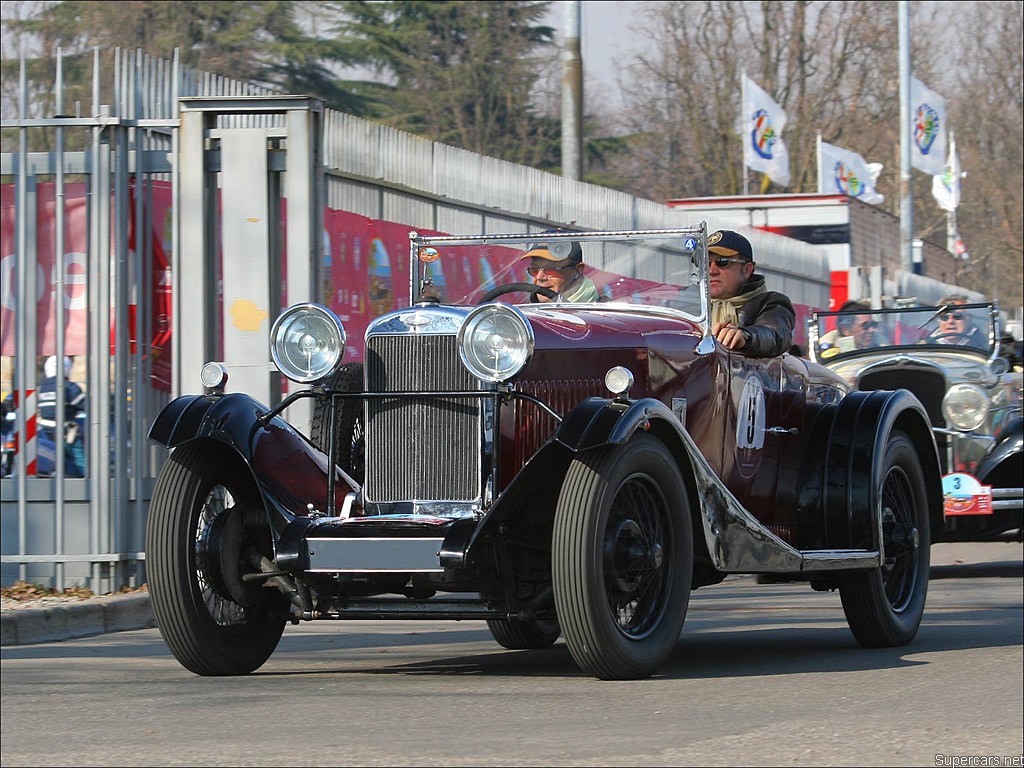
[459,302,534,382]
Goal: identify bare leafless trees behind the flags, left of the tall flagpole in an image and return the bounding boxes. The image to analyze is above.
[606,0,898,198]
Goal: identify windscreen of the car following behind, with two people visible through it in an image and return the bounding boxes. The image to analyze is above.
[811,304,994,361]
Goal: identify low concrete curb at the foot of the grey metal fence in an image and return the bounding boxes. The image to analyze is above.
[0,594,157,646]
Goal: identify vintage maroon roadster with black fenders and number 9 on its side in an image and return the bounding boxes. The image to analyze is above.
[146,225,943,679]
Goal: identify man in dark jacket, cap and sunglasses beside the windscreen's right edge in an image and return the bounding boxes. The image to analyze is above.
[708,229,797,357]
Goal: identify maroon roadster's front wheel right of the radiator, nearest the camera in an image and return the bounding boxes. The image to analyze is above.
[551,435,693,680]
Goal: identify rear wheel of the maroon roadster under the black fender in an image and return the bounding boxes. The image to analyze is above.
[840,431,932,648]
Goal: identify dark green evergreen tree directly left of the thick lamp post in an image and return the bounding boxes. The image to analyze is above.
[327,0,559,167]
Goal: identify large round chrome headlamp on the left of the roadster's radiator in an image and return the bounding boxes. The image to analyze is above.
[270,303,345,384]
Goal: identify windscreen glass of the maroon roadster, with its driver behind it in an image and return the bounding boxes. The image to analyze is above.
[407,233,701,318]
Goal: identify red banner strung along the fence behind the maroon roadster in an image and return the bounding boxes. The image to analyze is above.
[0,181,808,390]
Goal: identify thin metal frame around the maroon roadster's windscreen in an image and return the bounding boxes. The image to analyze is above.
[409,221,711,327]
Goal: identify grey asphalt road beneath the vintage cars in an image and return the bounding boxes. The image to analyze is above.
[0,550,1024,766]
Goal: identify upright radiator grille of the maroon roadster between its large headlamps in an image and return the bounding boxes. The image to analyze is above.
[365,335,482,503]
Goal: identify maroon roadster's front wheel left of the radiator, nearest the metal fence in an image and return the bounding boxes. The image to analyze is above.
[145,443,287,675]
